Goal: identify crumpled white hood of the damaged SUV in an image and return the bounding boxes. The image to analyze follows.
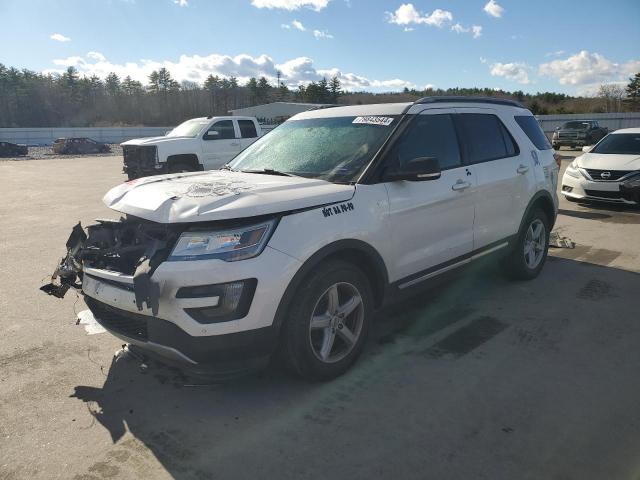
[103,170,355,223]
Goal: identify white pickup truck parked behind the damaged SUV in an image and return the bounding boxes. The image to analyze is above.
[121,117,263,180]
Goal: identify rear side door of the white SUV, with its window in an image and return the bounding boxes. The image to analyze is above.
[456,108,535,250]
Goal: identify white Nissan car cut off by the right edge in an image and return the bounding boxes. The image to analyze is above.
[562,128,640,204]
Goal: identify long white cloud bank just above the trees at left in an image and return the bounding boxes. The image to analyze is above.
[48,52,415,91]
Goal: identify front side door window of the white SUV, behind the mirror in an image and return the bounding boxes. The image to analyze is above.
[390,114,462,170]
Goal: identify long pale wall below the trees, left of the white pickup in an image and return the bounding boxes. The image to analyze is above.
[0,127,173,145]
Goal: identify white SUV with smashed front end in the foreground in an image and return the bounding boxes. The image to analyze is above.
[43,97,558,379]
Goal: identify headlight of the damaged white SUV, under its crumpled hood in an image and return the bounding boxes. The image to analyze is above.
[169,219,276,262]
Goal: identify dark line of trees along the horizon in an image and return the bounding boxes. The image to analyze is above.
[0,64,640,127]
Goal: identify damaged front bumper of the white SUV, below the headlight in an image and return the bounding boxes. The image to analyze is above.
[82,246,300,367]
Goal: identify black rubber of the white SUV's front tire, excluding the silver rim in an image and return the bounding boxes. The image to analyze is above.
[281,260,373,381]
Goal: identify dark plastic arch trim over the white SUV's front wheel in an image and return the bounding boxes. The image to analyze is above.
[273,239,389,329]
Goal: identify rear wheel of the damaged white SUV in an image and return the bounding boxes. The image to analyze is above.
[505,208,550,280]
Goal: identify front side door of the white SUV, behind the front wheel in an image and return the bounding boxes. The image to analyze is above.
[385,109,475,287]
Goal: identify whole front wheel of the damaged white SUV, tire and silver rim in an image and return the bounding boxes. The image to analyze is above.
[282,260,373,381]
